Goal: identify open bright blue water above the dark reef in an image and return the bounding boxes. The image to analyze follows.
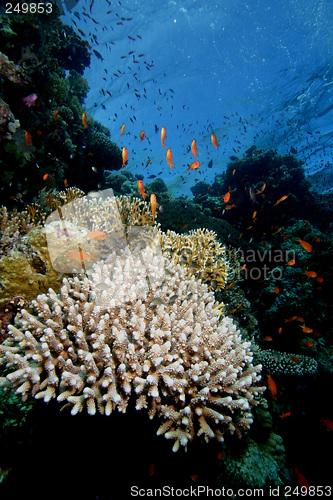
[62,0,333,196]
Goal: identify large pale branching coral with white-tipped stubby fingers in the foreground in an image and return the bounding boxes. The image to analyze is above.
[0,249,264,451]
